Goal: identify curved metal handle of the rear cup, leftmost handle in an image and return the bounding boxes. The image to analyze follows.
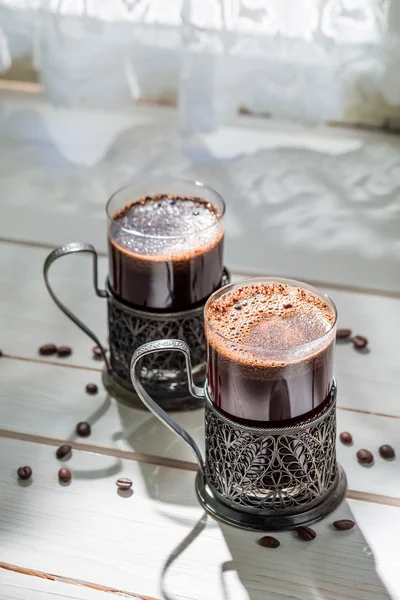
[43,242,111,371]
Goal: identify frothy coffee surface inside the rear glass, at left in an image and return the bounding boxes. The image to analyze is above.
[110,194,223,260]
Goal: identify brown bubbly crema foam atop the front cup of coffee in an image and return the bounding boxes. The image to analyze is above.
[205,282,335,380]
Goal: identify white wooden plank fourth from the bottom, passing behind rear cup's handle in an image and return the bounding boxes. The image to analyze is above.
[0,243,400,416]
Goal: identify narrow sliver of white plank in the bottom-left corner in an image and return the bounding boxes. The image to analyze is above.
[0,563,145,600]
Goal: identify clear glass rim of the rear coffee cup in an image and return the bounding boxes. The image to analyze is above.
[106,175,226,240]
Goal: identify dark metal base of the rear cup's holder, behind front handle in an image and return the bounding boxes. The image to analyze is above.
[102,368,204,412]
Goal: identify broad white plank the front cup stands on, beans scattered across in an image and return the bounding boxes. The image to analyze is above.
[0,439,400,600]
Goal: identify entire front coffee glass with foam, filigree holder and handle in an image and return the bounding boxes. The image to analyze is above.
[131,278,346,530]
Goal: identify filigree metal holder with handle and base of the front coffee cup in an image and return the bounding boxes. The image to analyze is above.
[131,340,346,531]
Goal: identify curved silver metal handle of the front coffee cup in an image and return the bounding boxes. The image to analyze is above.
[131,340,205,475]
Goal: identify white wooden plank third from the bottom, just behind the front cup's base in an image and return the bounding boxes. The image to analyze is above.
[0,359,400,498]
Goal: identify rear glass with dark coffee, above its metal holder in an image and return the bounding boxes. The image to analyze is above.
[107,177,225,311]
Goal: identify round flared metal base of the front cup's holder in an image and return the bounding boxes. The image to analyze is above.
[196,465,347,532]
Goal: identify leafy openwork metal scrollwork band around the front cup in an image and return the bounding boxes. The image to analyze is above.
[205,386,337,514]
